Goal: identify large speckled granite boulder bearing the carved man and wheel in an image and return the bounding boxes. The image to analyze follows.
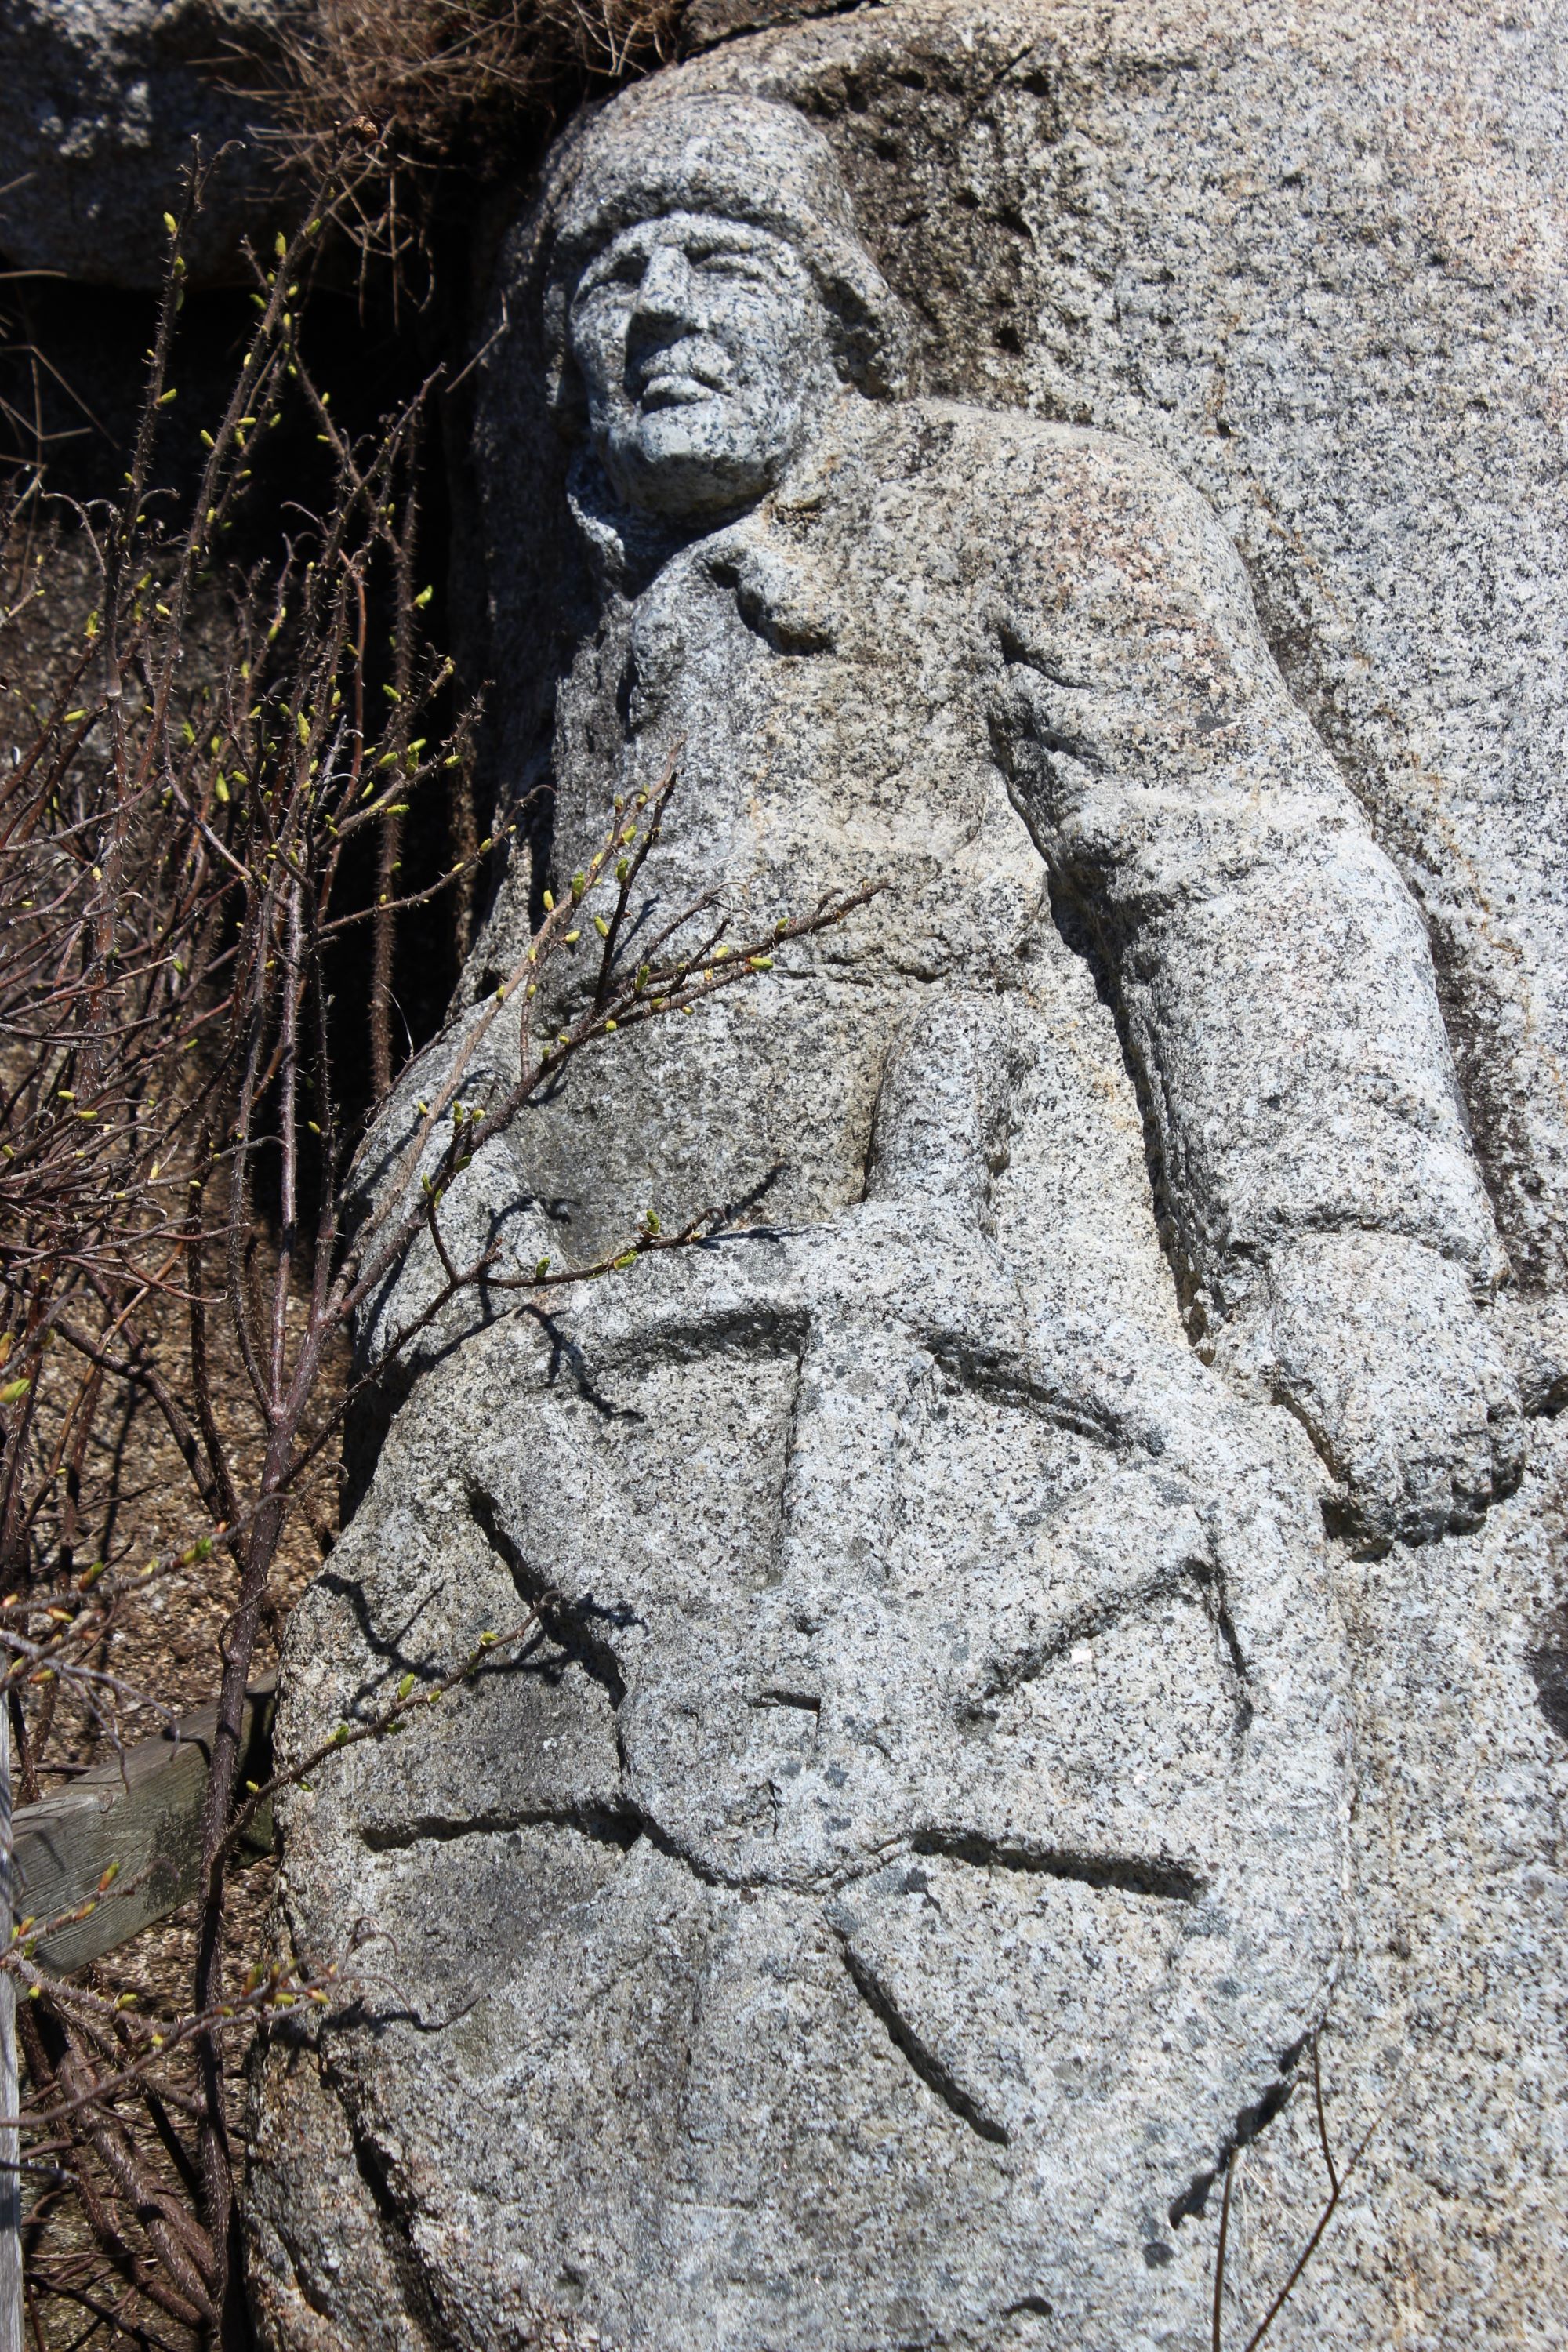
[249,7,1568,2352]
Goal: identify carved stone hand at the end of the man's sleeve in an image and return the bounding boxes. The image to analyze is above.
[1218,1232,1526,1548]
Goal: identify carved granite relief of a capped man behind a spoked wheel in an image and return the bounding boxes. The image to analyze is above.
[252,64,1523,2352]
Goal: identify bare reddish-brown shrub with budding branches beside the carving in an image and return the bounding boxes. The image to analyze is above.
[0,156,874,2343]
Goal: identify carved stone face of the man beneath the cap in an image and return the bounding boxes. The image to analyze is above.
[569,212,837,520]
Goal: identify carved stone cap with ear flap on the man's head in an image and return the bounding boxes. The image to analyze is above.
[543,87,912,414]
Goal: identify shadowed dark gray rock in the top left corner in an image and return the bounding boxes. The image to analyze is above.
[0,0,299,287]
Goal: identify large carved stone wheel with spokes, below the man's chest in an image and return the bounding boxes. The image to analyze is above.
[245,1197,1347,2352]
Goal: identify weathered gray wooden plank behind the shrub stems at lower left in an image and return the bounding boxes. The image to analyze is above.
[14,1675,275,1976]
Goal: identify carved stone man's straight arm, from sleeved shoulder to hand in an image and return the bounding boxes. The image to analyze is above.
[992,437,1521,1543]
